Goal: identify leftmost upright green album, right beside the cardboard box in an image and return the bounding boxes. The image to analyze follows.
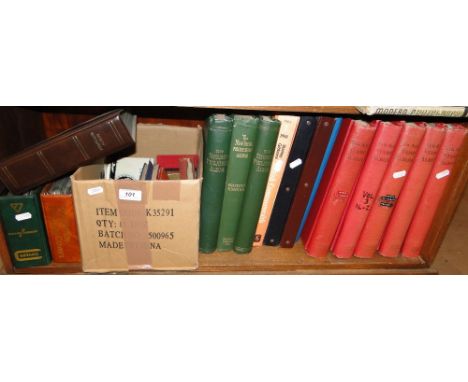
[200,114,233,253]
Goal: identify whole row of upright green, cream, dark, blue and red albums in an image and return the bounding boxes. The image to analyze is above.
[200,114,467,258]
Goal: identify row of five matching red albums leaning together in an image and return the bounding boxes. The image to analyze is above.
[302,119,466,258]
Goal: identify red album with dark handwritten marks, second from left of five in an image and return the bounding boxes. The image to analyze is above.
[332,121,404,258]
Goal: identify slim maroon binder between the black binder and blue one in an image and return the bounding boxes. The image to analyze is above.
[280,117,335,248]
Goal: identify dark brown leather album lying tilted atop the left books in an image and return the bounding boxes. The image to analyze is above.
[0,110,136,194]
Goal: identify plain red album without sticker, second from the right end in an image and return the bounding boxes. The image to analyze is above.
[379,123,446,257]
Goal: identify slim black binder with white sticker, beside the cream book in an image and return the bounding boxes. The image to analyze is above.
[263,117,317,246]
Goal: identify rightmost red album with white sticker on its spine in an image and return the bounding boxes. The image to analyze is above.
[402,124,467,257]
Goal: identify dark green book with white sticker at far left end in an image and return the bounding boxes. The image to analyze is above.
[0,189,51,268]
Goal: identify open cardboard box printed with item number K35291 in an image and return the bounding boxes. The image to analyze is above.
[72,124,203,273]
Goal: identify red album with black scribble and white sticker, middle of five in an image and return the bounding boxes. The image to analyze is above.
[354,123,426,258]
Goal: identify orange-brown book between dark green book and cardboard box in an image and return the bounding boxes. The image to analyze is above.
[41,178,81,263]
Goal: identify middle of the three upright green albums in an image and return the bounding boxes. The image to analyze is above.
[217,115,259,251]
